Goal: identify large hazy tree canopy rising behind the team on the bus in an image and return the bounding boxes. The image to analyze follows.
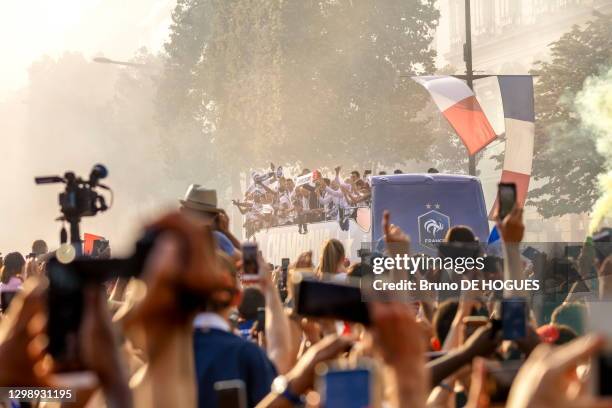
[158,0,439,179]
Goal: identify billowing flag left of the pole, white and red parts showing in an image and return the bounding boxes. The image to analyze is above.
[412,75,496,155]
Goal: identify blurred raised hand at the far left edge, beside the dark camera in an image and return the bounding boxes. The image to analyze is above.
[0,278,52,387]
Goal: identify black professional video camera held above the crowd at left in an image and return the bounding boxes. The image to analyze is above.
[34,164,112,255]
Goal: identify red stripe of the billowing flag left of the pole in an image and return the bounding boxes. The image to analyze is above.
[442,96,497,155]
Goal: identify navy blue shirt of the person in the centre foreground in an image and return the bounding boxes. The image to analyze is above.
[193,328,277,408]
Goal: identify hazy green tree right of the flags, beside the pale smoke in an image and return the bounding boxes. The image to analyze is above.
[529,14,612,218]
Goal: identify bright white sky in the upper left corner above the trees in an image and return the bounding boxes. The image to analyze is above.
[0,0,176,97]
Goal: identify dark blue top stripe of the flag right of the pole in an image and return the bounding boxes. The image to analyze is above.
[497,75,535,122]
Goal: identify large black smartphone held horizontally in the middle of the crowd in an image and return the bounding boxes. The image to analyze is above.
[295,278,370,325]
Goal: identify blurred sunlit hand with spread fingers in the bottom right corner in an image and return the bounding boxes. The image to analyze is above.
[506,336,612,408]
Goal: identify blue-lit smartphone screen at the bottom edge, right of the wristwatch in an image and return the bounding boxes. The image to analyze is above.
[321,368,372,408]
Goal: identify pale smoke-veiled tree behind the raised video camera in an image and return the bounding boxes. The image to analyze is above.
[15,50,171,248]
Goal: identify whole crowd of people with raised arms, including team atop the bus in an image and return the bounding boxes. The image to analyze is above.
[0,182,612,408]
